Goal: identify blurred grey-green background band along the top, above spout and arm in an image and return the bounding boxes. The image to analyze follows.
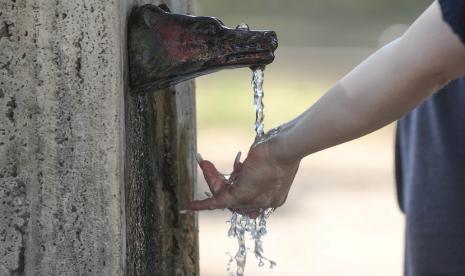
[193,0,433,47]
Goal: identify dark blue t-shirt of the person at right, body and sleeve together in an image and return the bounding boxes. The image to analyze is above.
[396,0,465,276]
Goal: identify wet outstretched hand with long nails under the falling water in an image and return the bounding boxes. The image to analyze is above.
[187,139,299,217]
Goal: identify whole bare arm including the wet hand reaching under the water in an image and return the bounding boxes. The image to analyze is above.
[189,2,465,213]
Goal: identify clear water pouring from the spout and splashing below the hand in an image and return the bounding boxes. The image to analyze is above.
[225,66,279,276]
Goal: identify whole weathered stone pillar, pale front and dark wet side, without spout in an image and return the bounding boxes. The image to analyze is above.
[0,0,198,276]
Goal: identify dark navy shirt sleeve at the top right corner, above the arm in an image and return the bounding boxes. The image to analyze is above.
[438,0,465,44]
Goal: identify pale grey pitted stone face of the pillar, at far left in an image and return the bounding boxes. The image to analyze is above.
[0,0,124,275]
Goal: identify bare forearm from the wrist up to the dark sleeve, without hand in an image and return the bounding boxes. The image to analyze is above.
[275,1,465,162]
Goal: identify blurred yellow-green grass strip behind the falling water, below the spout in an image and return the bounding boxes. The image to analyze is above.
[196,69,325,130]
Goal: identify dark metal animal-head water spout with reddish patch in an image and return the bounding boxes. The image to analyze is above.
[128,5,278,92]
